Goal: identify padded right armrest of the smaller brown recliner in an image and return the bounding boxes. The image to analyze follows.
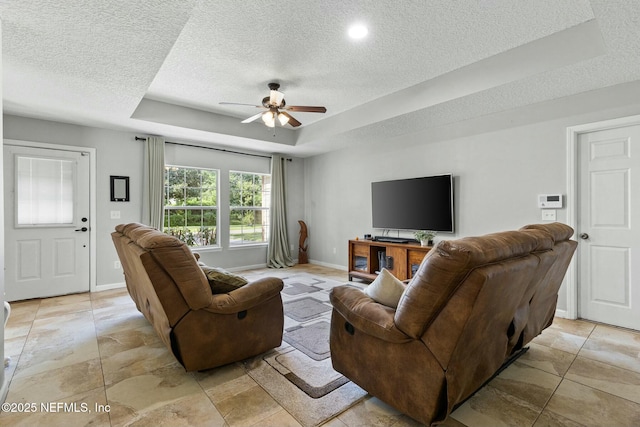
[203,277,284,314]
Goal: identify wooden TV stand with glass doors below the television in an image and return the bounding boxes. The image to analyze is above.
[349,240,431,282]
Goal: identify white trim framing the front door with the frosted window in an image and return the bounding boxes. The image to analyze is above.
[4,139,97,292]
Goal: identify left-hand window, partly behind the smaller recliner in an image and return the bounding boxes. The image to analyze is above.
[164,166,218,246]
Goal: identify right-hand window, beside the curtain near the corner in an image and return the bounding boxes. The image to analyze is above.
[229,172,271,245]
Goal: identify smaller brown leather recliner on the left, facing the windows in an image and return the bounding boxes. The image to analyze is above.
[111,223,284,371]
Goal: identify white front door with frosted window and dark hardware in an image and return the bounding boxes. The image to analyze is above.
[4,143,90,301]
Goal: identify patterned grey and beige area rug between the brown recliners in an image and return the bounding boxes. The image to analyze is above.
[244,274,367,427]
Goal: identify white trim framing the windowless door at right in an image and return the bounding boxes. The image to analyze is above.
[556,115,640,319]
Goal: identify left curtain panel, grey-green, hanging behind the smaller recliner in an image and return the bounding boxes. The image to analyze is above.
[142,136,164,230]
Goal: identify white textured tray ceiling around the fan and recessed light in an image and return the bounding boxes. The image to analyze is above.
[0,0,640,156]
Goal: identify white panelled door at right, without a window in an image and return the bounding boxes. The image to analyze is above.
[577,125,640,329]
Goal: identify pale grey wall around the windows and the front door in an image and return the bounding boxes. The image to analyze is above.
[4,115,304,288]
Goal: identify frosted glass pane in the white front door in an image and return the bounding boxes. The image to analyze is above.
[16,156,75,226]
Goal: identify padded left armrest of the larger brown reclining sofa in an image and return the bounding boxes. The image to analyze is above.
[329,285,412,343]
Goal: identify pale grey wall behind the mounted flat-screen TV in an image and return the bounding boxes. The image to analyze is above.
[305,104,640,310]
